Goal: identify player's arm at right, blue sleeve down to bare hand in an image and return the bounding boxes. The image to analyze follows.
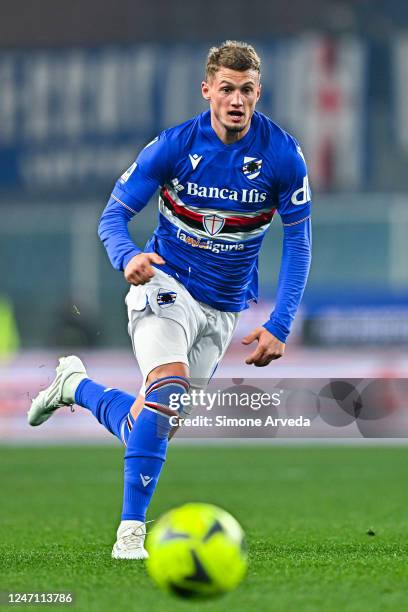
[242,139,311,366]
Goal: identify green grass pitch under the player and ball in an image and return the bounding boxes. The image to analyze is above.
[0,445,408,612]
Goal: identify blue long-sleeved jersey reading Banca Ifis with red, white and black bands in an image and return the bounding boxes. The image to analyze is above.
[99,111,311,342]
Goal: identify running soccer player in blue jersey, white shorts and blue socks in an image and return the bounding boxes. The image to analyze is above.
[28,41,311,559]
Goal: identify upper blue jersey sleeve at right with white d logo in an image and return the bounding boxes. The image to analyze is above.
[277,136,311,226]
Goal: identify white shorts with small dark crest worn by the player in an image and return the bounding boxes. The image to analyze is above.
[126,269,240,389]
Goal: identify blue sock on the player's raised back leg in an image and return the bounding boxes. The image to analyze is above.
[75,378,136,444]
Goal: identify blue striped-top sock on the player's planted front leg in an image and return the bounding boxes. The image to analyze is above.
[122,376,189,521]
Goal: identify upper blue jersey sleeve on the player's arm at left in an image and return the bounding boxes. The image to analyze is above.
[112,132,171,213]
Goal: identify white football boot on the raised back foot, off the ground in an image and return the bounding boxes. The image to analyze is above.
[27,355,88,426]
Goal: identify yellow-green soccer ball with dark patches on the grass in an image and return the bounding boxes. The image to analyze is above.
[146,503,247,599]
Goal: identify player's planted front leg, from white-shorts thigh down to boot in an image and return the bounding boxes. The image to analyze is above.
[112,304,194,559]
